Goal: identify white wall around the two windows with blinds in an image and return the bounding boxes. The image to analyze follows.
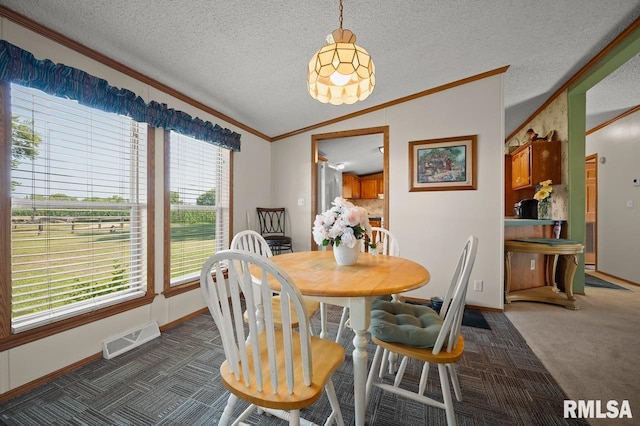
[0,18,271,394]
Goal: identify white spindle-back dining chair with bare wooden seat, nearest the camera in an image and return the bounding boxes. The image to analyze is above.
[200,250,345,425]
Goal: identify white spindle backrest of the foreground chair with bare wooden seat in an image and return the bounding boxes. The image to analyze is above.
[200,250,312,397]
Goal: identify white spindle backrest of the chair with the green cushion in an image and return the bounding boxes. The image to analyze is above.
[433,235,478,355]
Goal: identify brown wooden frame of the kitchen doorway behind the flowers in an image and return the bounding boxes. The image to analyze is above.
[309,126,390,250]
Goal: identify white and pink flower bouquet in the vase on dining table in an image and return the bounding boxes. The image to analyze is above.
[313,197,371,248]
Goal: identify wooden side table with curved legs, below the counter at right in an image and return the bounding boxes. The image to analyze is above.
[504,238,584,310]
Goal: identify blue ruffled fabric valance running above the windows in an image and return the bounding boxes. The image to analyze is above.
[0,40,240,151]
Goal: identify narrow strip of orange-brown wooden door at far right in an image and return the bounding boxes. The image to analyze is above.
[584,154,598,269]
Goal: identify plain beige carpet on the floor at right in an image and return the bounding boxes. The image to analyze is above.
[505,271,640,426]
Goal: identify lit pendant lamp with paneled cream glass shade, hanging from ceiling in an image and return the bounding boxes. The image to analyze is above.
[307,0,376,105]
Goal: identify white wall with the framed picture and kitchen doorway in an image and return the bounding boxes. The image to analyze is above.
[271,75,504,308]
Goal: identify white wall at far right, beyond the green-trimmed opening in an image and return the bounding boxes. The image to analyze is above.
[586,111,640,283]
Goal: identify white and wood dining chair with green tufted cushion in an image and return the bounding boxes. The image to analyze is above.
[366,236,478,425]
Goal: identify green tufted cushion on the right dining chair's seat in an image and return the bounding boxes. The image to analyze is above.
[369,299,442,349]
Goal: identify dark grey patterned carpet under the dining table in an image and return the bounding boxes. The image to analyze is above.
[0,308,586,426]
